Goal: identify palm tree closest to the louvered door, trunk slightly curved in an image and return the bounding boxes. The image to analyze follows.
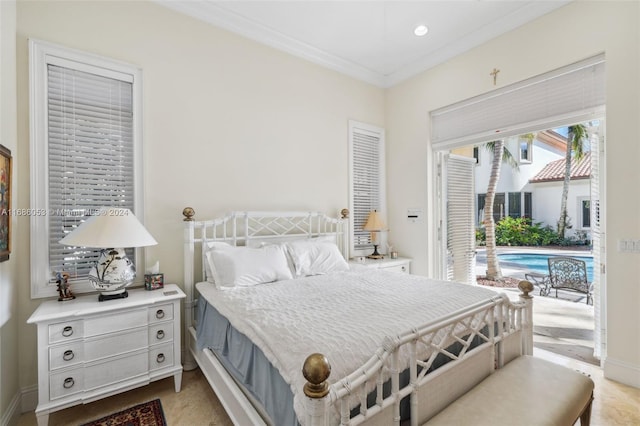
[483,133,534,281]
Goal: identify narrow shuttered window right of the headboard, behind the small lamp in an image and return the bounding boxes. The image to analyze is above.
[349,121,386,256]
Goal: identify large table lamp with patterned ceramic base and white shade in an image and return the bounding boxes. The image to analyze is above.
[60,207,158,302]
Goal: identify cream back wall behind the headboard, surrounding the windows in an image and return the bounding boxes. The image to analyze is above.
[14,1,385,396]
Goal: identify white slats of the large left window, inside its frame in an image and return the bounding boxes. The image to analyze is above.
[47,64,135,282]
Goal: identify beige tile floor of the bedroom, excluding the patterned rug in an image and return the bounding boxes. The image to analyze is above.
[18,348,640,426]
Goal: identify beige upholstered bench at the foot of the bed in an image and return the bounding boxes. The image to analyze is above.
[425,356,594,426]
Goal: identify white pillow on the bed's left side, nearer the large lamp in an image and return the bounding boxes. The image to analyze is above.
[206,245,293,287]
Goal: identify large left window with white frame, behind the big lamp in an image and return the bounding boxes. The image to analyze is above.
[29,40,144,298]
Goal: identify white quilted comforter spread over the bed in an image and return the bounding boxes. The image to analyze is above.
[197,268,496,422]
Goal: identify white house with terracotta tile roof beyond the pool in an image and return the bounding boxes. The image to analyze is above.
[474,130,591,240]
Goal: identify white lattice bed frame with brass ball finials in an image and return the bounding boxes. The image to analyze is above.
[183,207,533,426]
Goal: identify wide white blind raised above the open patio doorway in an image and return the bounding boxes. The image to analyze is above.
[431,55,605,150]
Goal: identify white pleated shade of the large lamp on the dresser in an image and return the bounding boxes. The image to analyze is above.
[60,207,158,248]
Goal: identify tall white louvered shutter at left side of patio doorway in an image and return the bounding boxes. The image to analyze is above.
[443,154,476,284]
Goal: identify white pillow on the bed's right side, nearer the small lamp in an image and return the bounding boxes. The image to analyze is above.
[287,239,349,277]
